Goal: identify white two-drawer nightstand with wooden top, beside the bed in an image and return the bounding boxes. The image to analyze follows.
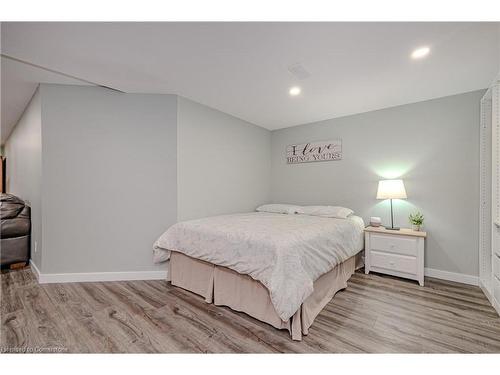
[365,227,427,286]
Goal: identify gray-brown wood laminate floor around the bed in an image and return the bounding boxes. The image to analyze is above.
[0,268,500,353]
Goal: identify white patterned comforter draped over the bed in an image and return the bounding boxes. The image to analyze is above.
[154,212,364,321]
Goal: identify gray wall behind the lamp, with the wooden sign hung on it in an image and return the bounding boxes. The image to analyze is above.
[271,90,484,275]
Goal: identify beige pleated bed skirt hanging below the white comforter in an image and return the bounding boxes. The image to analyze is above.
[169,251,363,341]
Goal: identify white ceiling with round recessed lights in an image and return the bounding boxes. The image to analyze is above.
[2,22,500,142]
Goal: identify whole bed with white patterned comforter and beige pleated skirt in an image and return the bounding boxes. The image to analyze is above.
[154,212,364,340]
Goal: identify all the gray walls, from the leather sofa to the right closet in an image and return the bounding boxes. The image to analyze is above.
[1,85,483,275]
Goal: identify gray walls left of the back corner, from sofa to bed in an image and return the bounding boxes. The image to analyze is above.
[5,88,271,274]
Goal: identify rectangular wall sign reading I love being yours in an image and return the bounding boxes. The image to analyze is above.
[286,139,342,164]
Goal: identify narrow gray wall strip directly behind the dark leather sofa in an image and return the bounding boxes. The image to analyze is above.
[4,90,42,267]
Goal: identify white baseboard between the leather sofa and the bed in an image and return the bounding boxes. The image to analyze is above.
[30,260,168,284]
